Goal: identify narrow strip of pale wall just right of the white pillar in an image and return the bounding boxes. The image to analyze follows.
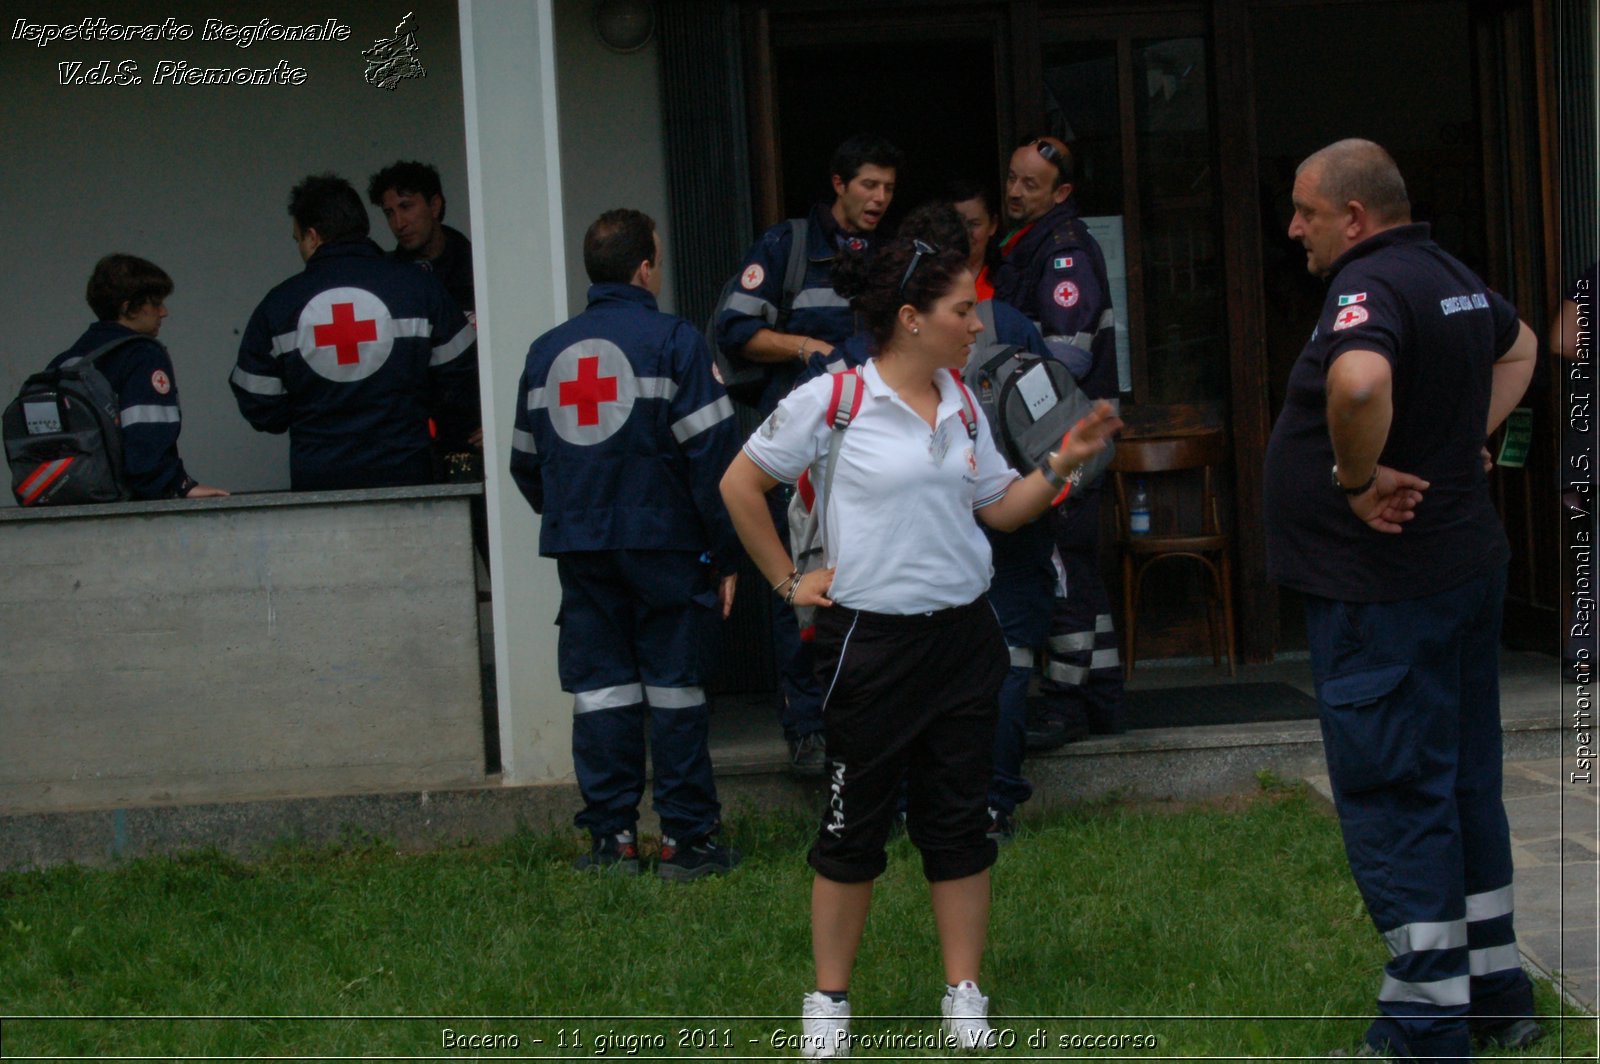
[555,0,677,314]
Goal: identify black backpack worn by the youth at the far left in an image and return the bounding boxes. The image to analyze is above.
[0,336,136,506]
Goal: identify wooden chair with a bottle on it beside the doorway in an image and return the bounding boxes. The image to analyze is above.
[1110,430,1234,677]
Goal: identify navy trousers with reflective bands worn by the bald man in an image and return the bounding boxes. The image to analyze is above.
[1306,568,1533,1061]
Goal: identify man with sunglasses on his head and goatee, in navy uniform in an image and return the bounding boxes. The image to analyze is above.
[994,136,1122,749]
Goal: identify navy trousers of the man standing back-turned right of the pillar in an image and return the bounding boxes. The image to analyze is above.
[555,550,722,842]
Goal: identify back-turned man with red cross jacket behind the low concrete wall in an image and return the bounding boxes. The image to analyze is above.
[229,174,478,491]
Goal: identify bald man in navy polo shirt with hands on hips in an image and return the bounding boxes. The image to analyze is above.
[1264,141,1542,1061]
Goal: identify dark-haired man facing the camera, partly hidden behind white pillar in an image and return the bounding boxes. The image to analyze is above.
[366,162,477,315]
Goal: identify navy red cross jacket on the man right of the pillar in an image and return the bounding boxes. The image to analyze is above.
[510,285,741,573]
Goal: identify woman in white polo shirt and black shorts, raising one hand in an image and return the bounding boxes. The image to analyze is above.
[722,232,1120,1058]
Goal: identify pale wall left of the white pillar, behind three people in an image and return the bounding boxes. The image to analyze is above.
[0,0,472,504]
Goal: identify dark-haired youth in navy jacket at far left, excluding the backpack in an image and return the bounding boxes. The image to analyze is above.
[50,254,227,499]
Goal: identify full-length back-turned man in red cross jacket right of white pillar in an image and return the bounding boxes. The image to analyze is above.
[510,210,742,880]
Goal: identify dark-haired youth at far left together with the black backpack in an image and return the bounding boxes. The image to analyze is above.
[6,254,227,506]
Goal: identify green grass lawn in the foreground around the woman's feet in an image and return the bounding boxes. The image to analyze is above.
[0,787,1595,1059]
